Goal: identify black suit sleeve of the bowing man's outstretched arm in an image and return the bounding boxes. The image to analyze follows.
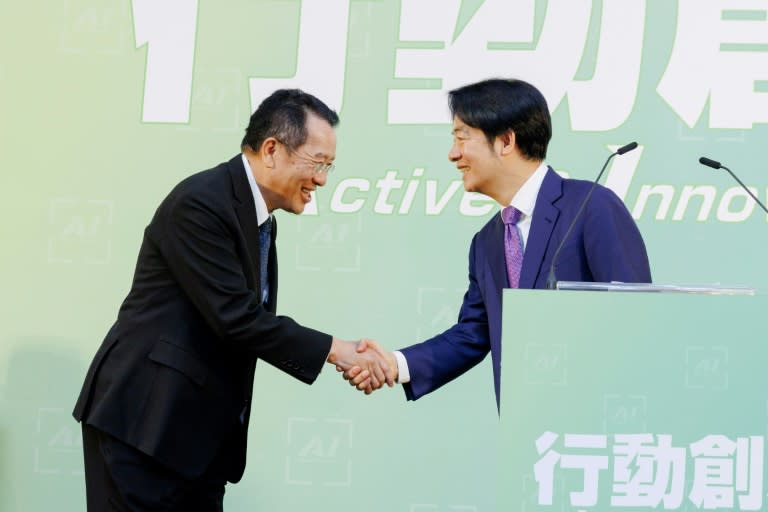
[160,190,331,382]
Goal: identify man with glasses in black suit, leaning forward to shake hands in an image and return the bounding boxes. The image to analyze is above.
[74,90,394,511]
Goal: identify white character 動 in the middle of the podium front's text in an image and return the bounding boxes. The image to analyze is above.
[611,434,685,509]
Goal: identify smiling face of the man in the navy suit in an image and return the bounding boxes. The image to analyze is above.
[448,117,503,197]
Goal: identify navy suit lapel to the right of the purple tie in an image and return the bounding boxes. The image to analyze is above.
[520,167,563,289]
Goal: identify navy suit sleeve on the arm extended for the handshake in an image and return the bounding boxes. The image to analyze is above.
[401,235,490,400]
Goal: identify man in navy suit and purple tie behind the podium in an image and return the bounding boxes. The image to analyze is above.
[344,79,651,406]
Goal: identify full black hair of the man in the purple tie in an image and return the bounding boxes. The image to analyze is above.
[448,78,552,160]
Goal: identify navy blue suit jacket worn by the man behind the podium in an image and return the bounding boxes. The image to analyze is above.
[401,168,651,406]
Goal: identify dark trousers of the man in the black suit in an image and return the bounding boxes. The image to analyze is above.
[83,423,226,512]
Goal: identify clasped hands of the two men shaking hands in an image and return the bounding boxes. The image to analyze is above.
[327,338,398,395]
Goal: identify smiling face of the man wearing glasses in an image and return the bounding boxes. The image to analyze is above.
[262,114,336,213]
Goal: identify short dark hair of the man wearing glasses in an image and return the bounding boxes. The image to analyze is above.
[240,89,339,151]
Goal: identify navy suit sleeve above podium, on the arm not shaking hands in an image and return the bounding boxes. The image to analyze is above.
[584,187,651,283]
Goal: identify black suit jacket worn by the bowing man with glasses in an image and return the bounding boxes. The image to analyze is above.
[73,155,331,482]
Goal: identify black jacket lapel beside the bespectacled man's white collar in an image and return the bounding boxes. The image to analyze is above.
[228,155,260,294]
